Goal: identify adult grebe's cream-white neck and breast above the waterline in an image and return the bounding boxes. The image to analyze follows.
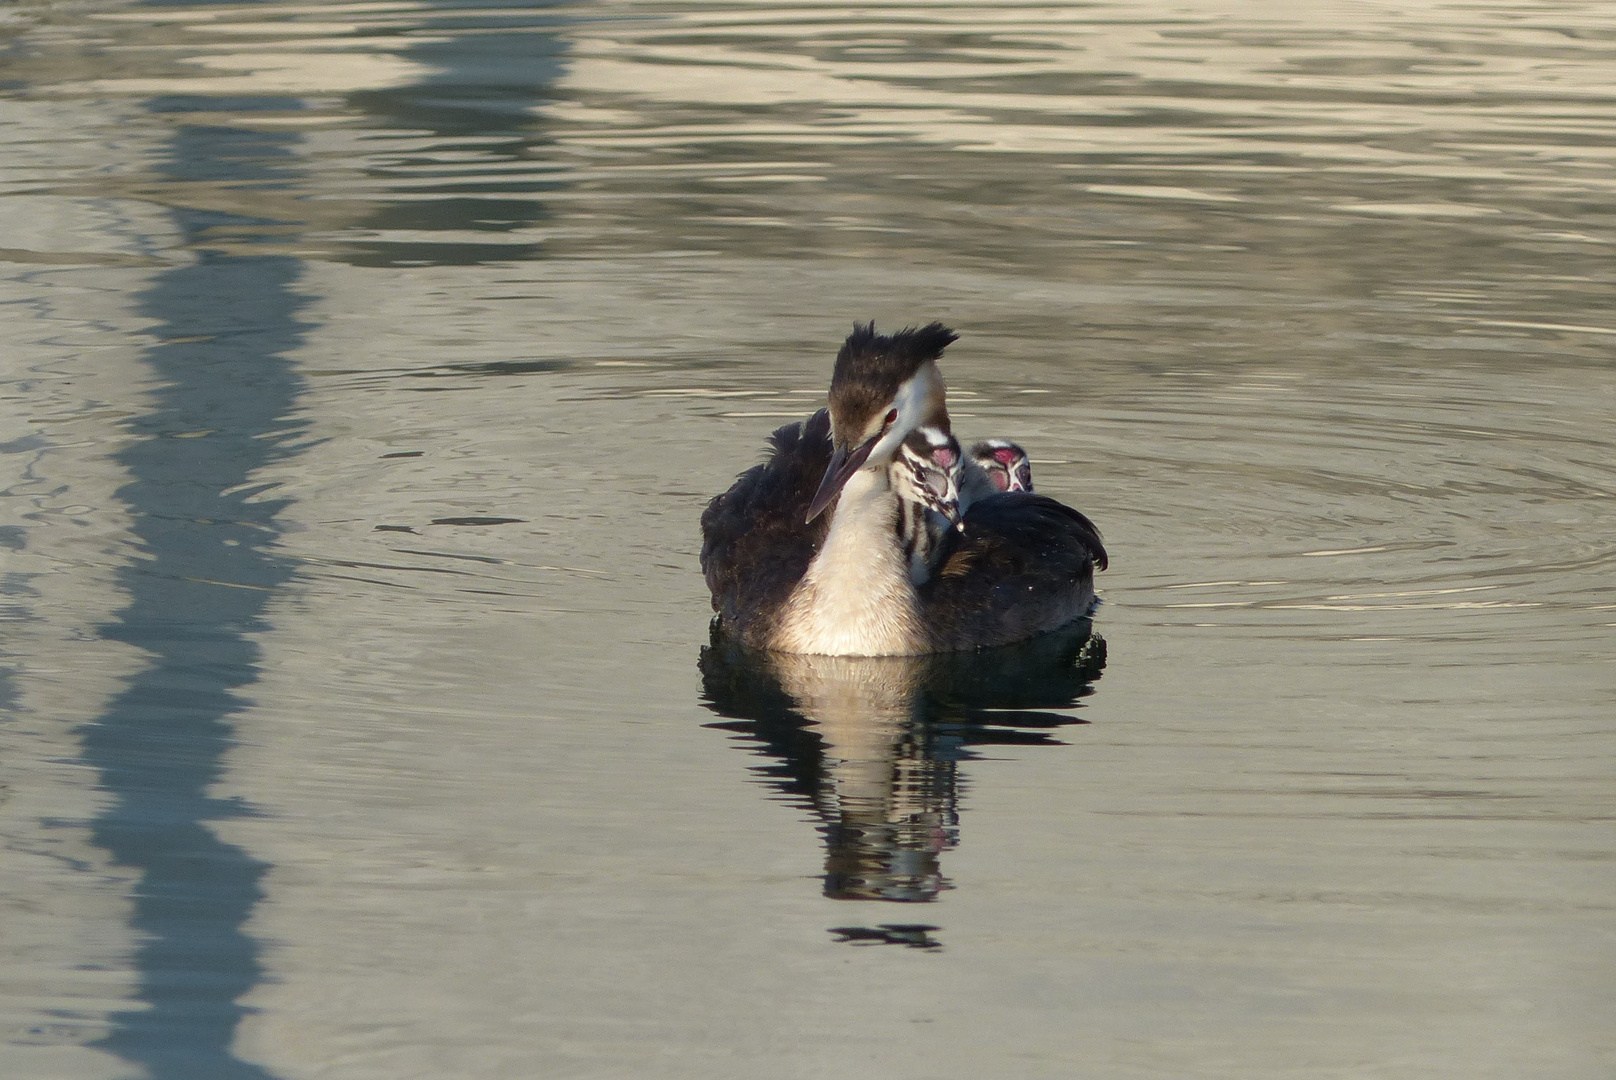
[771,467,928,656]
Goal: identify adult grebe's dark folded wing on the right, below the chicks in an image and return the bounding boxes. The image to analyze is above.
[920,491,1107,650]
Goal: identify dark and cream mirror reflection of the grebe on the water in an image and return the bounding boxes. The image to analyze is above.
[700,619,1105,902]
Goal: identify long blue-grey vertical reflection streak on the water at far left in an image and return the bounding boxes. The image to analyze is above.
[82,103,302,1080]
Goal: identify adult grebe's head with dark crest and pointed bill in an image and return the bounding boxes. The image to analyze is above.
[808,322,958,521]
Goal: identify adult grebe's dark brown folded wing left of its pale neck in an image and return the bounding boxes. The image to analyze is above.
[701,409,831,643]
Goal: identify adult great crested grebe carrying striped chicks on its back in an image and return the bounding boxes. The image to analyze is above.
[701,323,1107,656]
